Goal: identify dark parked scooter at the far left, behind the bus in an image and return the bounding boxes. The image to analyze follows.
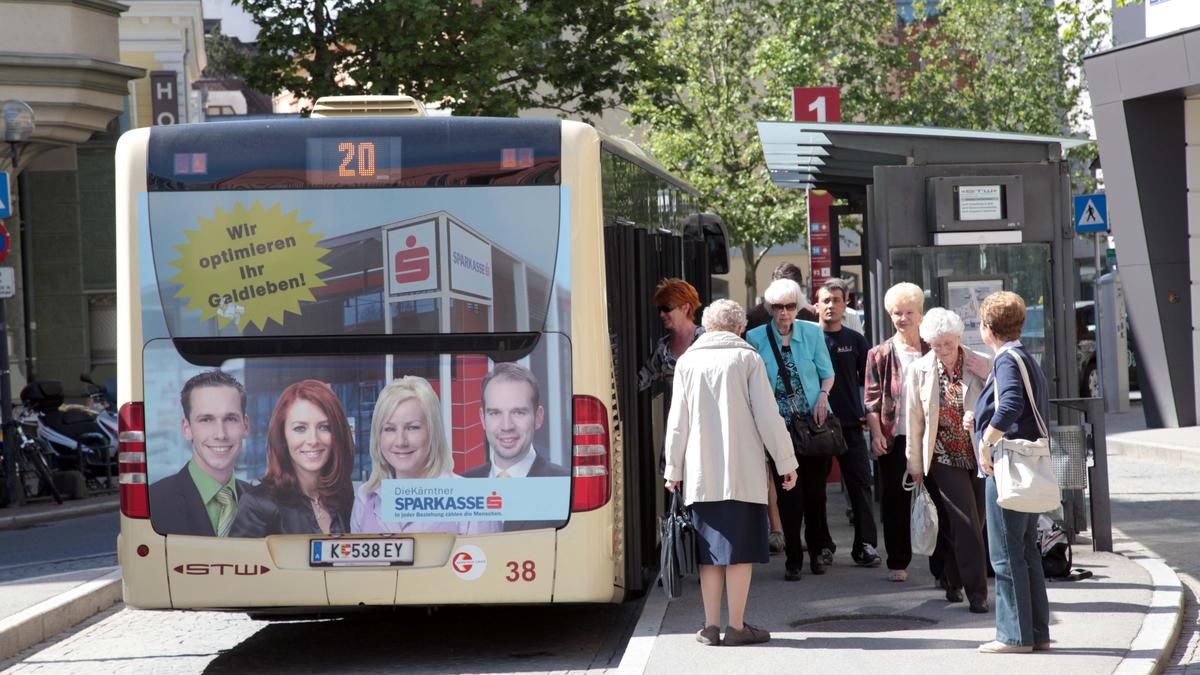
[18,380,118,497]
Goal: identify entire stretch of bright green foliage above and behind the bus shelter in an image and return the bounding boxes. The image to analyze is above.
[631,0,1108,297]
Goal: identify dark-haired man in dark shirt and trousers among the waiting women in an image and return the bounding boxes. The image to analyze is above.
[817,279,880,567]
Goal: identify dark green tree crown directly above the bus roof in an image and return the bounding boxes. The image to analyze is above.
[229,0,664,118]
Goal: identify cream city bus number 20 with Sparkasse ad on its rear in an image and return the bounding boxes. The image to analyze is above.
[116,97,728,615]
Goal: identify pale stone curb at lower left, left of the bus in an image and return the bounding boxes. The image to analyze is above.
[0,568,121,661]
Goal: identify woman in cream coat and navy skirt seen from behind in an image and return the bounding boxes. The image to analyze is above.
[664,300,796,646]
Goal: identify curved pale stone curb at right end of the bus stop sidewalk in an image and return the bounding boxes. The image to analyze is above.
[1112,556,1183,675]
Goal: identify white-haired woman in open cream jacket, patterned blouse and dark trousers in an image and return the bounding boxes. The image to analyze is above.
[904,307,988,614]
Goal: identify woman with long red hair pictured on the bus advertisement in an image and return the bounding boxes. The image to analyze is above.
[229,380,354,537]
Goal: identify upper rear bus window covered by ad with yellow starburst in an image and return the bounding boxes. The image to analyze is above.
[142,186,565,338]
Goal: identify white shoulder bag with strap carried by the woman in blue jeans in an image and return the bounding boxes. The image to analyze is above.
[992,354,1062,513]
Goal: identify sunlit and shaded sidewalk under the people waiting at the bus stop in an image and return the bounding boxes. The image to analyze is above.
[622,490,1183,675]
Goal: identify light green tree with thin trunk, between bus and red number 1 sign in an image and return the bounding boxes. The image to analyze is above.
[630,0,896,304]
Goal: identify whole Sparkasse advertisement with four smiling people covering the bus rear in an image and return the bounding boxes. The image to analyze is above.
[142,186,571,540]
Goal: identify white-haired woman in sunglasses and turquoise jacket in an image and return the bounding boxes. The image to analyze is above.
[746,279,834,581]
